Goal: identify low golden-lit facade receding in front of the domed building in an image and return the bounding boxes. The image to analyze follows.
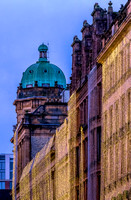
[20,120,70,200]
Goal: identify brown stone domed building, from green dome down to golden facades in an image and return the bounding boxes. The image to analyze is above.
[11,44,67,196]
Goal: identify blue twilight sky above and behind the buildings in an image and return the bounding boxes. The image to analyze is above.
[0,0,126,153]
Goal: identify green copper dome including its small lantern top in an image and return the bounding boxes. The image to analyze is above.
[21,44,66,88]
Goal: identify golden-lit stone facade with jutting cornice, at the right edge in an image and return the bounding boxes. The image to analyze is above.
[97,1,131,200]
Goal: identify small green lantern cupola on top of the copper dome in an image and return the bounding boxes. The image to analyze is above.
[38,43,48,61]
